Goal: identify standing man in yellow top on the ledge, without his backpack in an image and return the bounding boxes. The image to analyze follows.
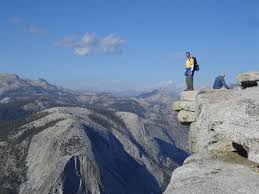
[184,52,195,91]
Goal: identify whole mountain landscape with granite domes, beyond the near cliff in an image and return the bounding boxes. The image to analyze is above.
[0,74,188,194]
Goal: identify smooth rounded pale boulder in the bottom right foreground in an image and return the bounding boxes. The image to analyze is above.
[164,152,259,194]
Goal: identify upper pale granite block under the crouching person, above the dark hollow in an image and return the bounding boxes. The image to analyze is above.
[196,87,259,163]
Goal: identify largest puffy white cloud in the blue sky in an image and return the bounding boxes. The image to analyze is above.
[54,32,125,56]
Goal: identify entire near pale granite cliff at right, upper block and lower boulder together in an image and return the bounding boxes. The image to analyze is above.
[164,79,259,194]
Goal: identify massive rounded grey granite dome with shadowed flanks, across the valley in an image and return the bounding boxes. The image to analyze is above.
[2,108,178,194]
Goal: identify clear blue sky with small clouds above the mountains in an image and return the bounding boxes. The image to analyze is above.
[0,0,259,89]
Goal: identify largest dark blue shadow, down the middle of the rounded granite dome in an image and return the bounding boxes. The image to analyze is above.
[85,126,162,194]
